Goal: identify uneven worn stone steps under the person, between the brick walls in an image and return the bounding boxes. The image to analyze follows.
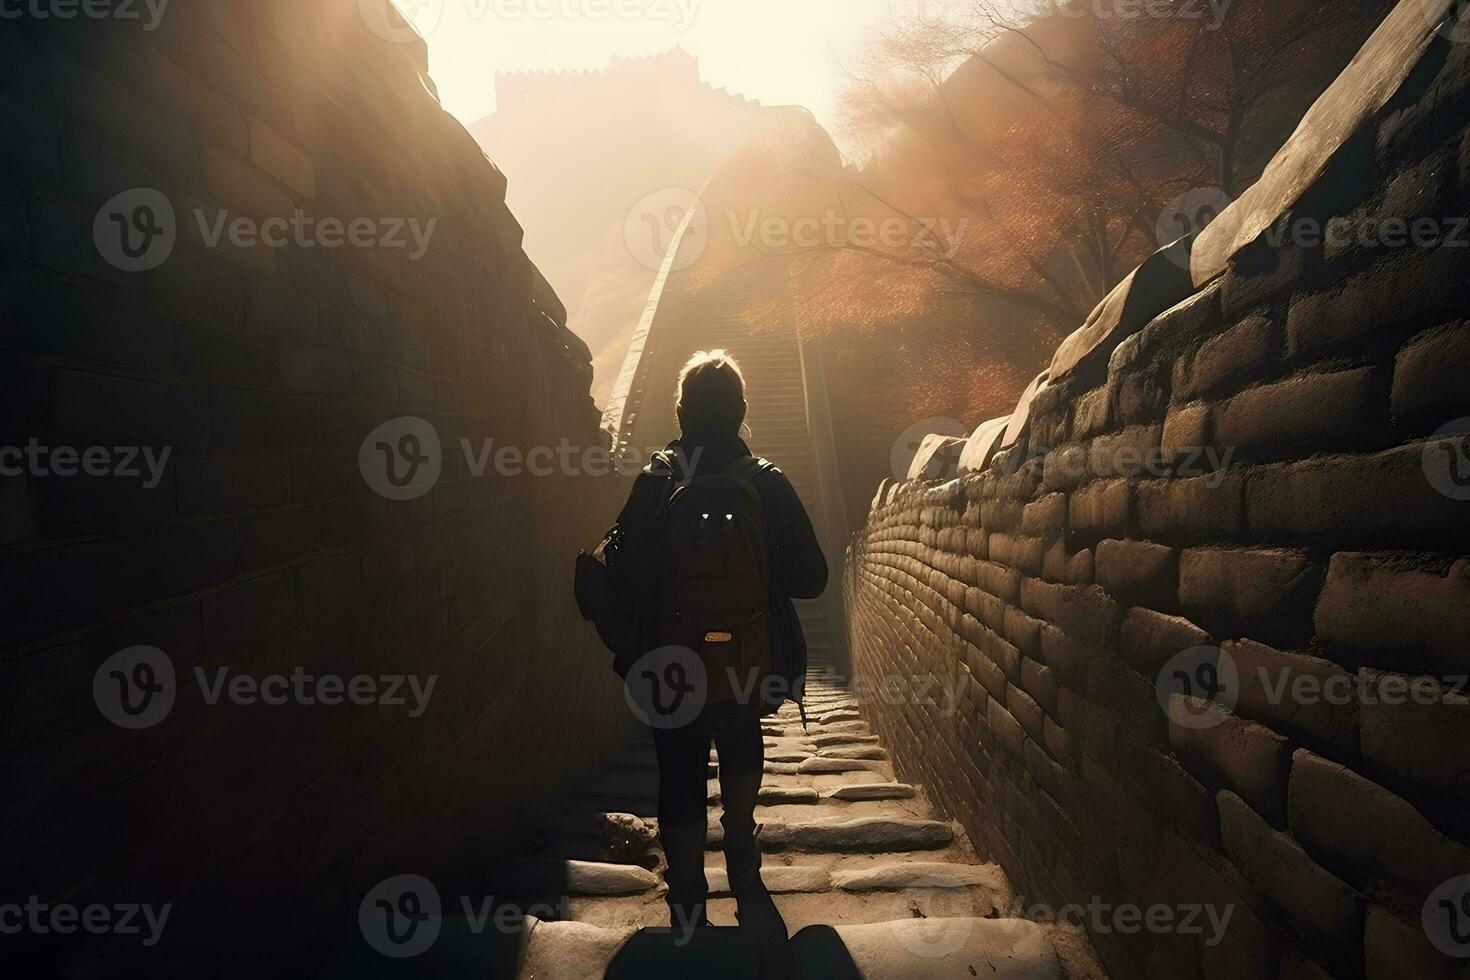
[519,679,1101,980]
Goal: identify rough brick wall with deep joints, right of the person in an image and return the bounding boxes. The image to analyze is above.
[847,4,1470,977]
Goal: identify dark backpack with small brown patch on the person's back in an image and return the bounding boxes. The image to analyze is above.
[650,455,775,704]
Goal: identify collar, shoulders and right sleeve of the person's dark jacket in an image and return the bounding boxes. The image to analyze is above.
[617,436,828,696]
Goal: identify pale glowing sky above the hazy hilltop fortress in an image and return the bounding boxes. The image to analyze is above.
[394,0,899,138]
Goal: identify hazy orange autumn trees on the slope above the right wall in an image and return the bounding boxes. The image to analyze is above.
[676,0,1391,423]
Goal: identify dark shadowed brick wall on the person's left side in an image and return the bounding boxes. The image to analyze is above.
[0,0,631,976]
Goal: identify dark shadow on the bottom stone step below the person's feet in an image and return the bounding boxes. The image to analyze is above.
[603,926,861,980]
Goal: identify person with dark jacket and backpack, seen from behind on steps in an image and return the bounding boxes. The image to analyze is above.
[579,350,828,940]
